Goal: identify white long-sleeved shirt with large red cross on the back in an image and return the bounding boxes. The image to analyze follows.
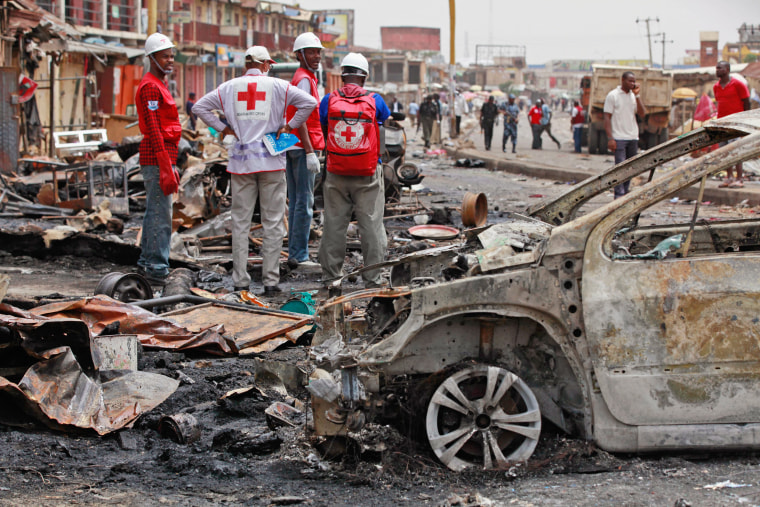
[193,69,317,174]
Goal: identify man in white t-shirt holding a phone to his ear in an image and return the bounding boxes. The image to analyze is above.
[604,71,647,199]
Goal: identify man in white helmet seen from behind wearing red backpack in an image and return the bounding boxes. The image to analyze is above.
[319,53,391,288]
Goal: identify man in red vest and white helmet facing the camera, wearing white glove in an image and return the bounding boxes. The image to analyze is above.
[285,32,325,271]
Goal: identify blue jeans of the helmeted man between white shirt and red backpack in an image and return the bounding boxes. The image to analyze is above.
[285,150,315,262]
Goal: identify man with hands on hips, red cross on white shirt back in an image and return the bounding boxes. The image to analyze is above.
[193,46,317,295]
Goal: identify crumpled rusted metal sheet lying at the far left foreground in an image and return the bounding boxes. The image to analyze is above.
[0,305,179,435]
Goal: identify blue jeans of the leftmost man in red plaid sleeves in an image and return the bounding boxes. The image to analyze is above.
[137,165,172,278]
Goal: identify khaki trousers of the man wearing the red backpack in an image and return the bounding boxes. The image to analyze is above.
[319,165,388,287]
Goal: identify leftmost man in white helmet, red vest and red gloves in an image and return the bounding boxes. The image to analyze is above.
[135,33,182,285]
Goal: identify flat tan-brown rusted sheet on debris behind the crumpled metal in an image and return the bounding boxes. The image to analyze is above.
[163,303,314,350]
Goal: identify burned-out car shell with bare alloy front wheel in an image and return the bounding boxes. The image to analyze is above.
[310,111,760,470]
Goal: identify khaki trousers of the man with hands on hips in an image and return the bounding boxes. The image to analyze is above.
[230,170,288,287]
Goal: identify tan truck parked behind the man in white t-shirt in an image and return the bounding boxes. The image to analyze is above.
[581,65,673,155]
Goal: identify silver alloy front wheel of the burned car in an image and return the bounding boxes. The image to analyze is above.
[425,365,541,471]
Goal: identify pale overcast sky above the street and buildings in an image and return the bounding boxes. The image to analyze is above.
[296,0,760,64]
